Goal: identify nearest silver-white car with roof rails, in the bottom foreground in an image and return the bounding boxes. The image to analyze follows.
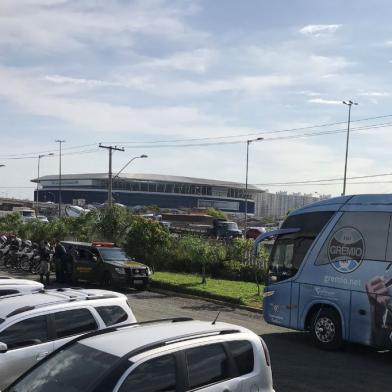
[0,318,273,392]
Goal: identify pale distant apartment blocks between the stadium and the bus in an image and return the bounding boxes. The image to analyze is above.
[255,191,331,219]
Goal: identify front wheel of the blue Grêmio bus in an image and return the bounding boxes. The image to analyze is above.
[311,308,342,350]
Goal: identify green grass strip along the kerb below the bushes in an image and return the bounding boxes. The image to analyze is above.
[152,272,263,308]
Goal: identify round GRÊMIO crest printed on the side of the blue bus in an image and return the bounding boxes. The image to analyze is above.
[328,227,365,274]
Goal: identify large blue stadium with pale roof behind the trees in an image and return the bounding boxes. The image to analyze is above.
[32,173,263,214]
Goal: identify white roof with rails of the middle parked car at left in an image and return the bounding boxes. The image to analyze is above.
[0,288,126,320]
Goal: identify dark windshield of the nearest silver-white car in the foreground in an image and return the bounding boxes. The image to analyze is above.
[9,343,118,392]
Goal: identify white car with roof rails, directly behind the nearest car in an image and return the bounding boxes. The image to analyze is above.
[0,289,136,390]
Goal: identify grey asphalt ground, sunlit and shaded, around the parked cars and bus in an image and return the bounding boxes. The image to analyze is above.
[0,269,392,392]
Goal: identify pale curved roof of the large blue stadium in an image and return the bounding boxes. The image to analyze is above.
[31,173,264,192]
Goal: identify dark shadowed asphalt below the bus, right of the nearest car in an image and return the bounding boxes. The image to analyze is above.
[262,332,392,392]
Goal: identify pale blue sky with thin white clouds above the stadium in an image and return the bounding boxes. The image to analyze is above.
[0,0,392,199]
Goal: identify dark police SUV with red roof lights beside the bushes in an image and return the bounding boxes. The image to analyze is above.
[61,241,151,290]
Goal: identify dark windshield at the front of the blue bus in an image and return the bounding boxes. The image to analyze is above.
[268,211,334,283]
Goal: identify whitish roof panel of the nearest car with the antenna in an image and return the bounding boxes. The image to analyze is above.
[79,319,249,357]
